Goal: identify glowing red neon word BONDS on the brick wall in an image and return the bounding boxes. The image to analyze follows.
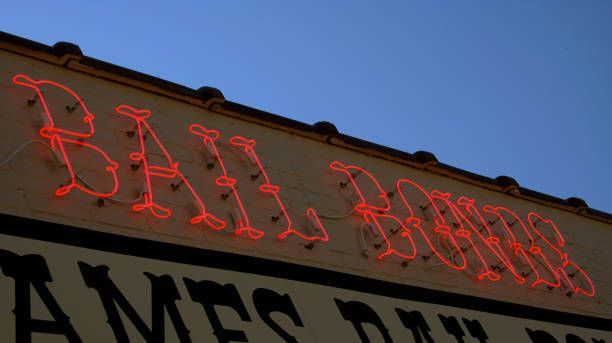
[329,161,595,297]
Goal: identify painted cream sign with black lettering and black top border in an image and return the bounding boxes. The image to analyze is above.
[0,215,612,343]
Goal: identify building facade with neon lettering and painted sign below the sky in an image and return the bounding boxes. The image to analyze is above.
[0,33,612,342]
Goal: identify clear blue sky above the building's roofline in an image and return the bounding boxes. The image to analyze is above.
[0,0,612,212]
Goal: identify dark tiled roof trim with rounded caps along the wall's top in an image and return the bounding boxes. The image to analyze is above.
[0,31,612,223]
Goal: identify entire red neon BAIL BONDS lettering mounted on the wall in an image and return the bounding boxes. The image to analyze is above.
[12,74,595,297]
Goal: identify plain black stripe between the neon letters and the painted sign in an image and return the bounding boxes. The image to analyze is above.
[0,214,612,331]
